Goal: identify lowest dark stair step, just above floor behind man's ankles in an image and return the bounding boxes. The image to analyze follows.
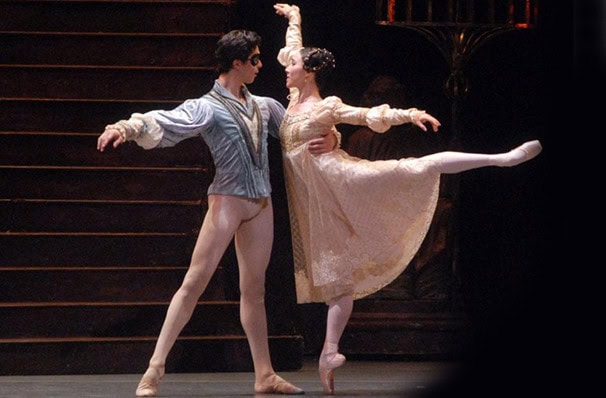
[0,335,303,376]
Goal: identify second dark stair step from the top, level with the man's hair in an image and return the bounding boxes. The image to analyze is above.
[0,32,220,69]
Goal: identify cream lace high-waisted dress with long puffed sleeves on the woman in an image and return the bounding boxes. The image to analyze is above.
[278,6,440,303]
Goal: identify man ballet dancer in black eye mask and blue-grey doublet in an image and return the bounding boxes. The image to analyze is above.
[97,30,336,397]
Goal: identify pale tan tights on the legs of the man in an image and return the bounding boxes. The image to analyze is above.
[149,195,275,384]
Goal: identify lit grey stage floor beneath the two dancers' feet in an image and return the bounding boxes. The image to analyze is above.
[0,359,459,398]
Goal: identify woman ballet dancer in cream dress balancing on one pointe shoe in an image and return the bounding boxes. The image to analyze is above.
[274,3,542,394]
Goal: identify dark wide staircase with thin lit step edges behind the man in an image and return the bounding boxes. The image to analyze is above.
[0,0,303,375]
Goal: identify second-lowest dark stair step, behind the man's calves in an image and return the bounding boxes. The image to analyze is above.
[0,300,244,340]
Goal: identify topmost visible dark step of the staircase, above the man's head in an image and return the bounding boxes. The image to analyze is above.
[0,0,234,33]
